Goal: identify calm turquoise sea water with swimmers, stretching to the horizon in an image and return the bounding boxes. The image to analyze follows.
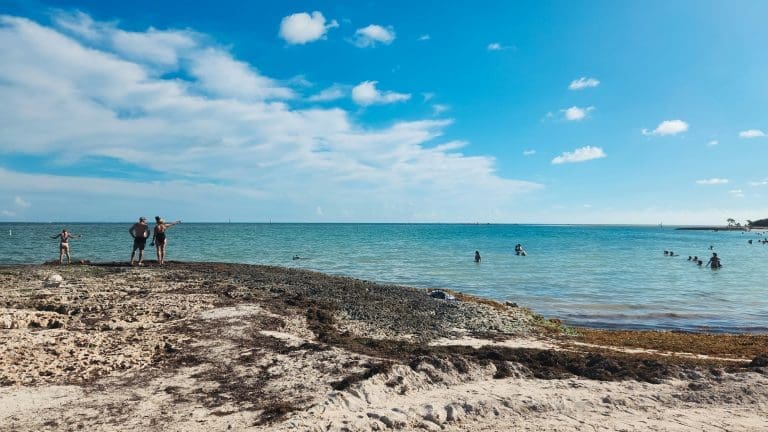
[0,223,768,332]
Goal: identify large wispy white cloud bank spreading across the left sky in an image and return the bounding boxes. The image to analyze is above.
[0,16,542,221]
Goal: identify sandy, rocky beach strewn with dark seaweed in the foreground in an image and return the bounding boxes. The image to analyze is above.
[0,262,768,431]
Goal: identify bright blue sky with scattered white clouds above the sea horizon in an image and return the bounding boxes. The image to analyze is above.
[0,0,768,225]
